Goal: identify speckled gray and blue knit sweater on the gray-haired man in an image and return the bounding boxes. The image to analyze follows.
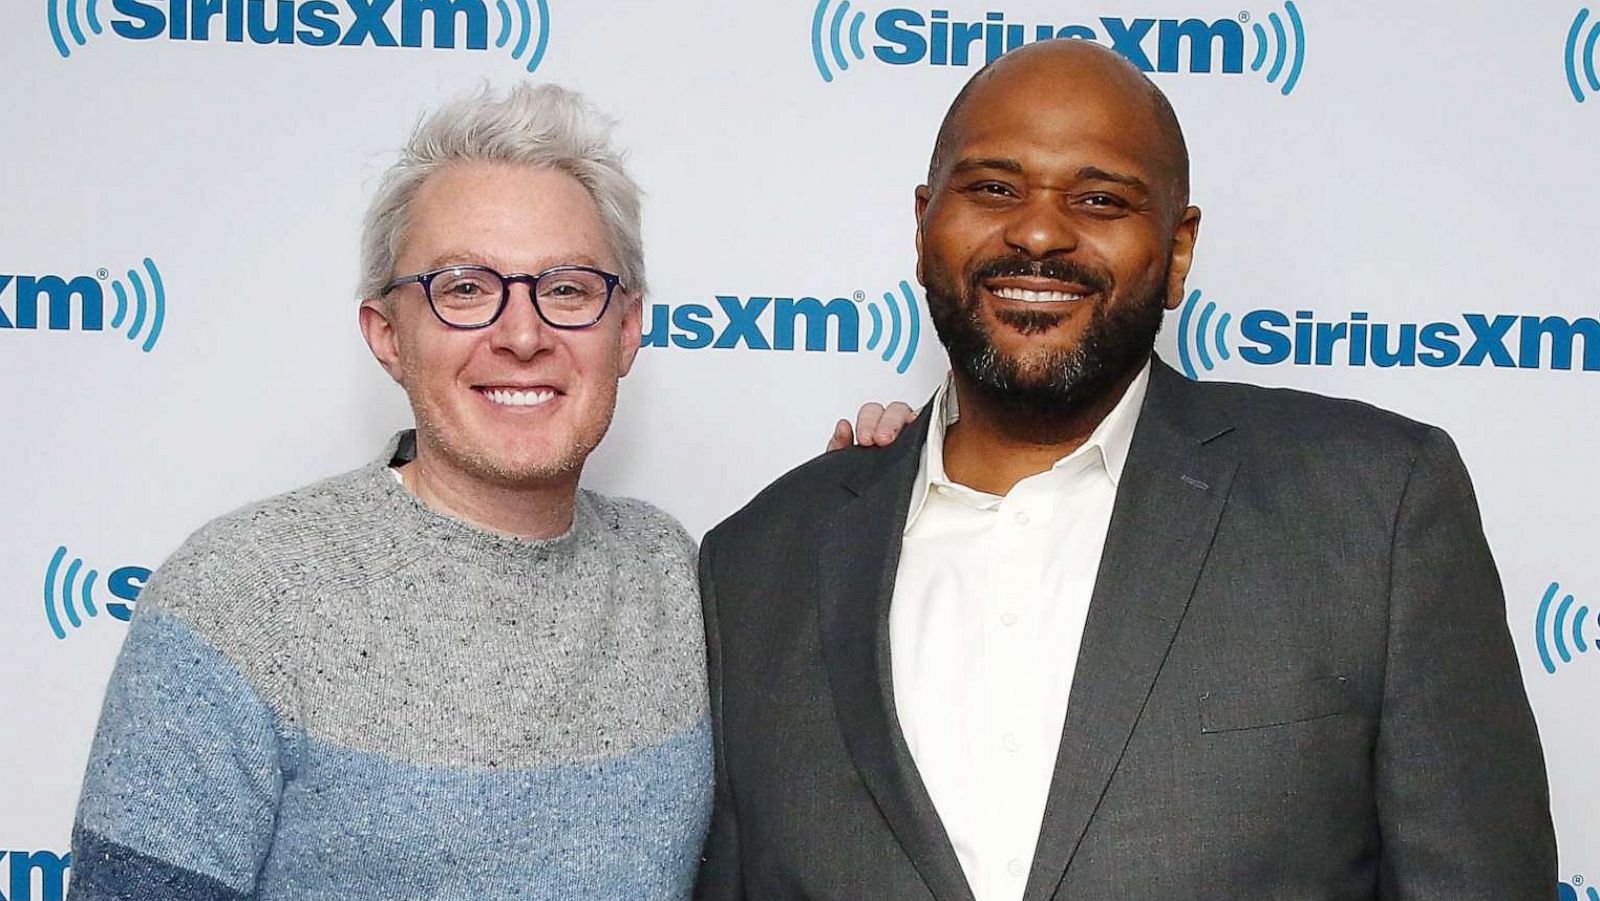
[70,432,712,901]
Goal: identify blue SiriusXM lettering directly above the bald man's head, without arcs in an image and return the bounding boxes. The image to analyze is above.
[872,8,1245,74]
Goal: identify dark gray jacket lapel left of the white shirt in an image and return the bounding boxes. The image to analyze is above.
[818,410,973,901]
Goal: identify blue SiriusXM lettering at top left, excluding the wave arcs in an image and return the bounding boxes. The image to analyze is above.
[110,0,490,50]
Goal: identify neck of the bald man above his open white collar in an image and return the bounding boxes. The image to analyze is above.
[944,362,1144,495]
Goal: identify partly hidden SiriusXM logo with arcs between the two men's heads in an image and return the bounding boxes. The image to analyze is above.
[645,280,922,373]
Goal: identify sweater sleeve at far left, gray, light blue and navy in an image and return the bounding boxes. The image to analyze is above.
[69,524,294,901]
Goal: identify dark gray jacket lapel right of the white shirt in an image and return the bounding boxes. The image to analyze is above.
[1024,360,1237,901]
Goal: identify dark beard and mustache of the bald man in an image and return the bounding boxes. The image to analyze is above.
[925,256,1168,422]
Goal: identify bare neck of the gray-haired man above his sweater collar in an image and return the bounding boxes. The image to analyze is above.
[398,438,578,538]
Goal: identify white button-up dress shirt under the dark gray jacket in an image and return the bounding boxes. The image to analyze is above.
[890,365,1150,901]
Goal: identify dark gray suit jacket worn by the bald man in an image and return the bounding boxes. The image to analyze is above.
[698,362,1557,901]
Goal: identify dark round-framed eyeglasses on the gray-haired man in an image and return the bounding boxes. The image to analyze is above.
[384,266,622,328]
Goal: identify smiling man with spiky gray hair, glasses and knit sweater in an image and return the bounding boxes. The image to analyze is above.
[70,86,712,901]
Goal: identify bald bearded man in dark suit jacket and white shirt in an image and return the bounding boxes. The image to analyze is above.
[698,42,1555,901]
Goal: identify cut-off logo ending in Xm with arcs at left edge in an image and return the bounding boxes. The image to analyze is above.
[0,258,166,354]
